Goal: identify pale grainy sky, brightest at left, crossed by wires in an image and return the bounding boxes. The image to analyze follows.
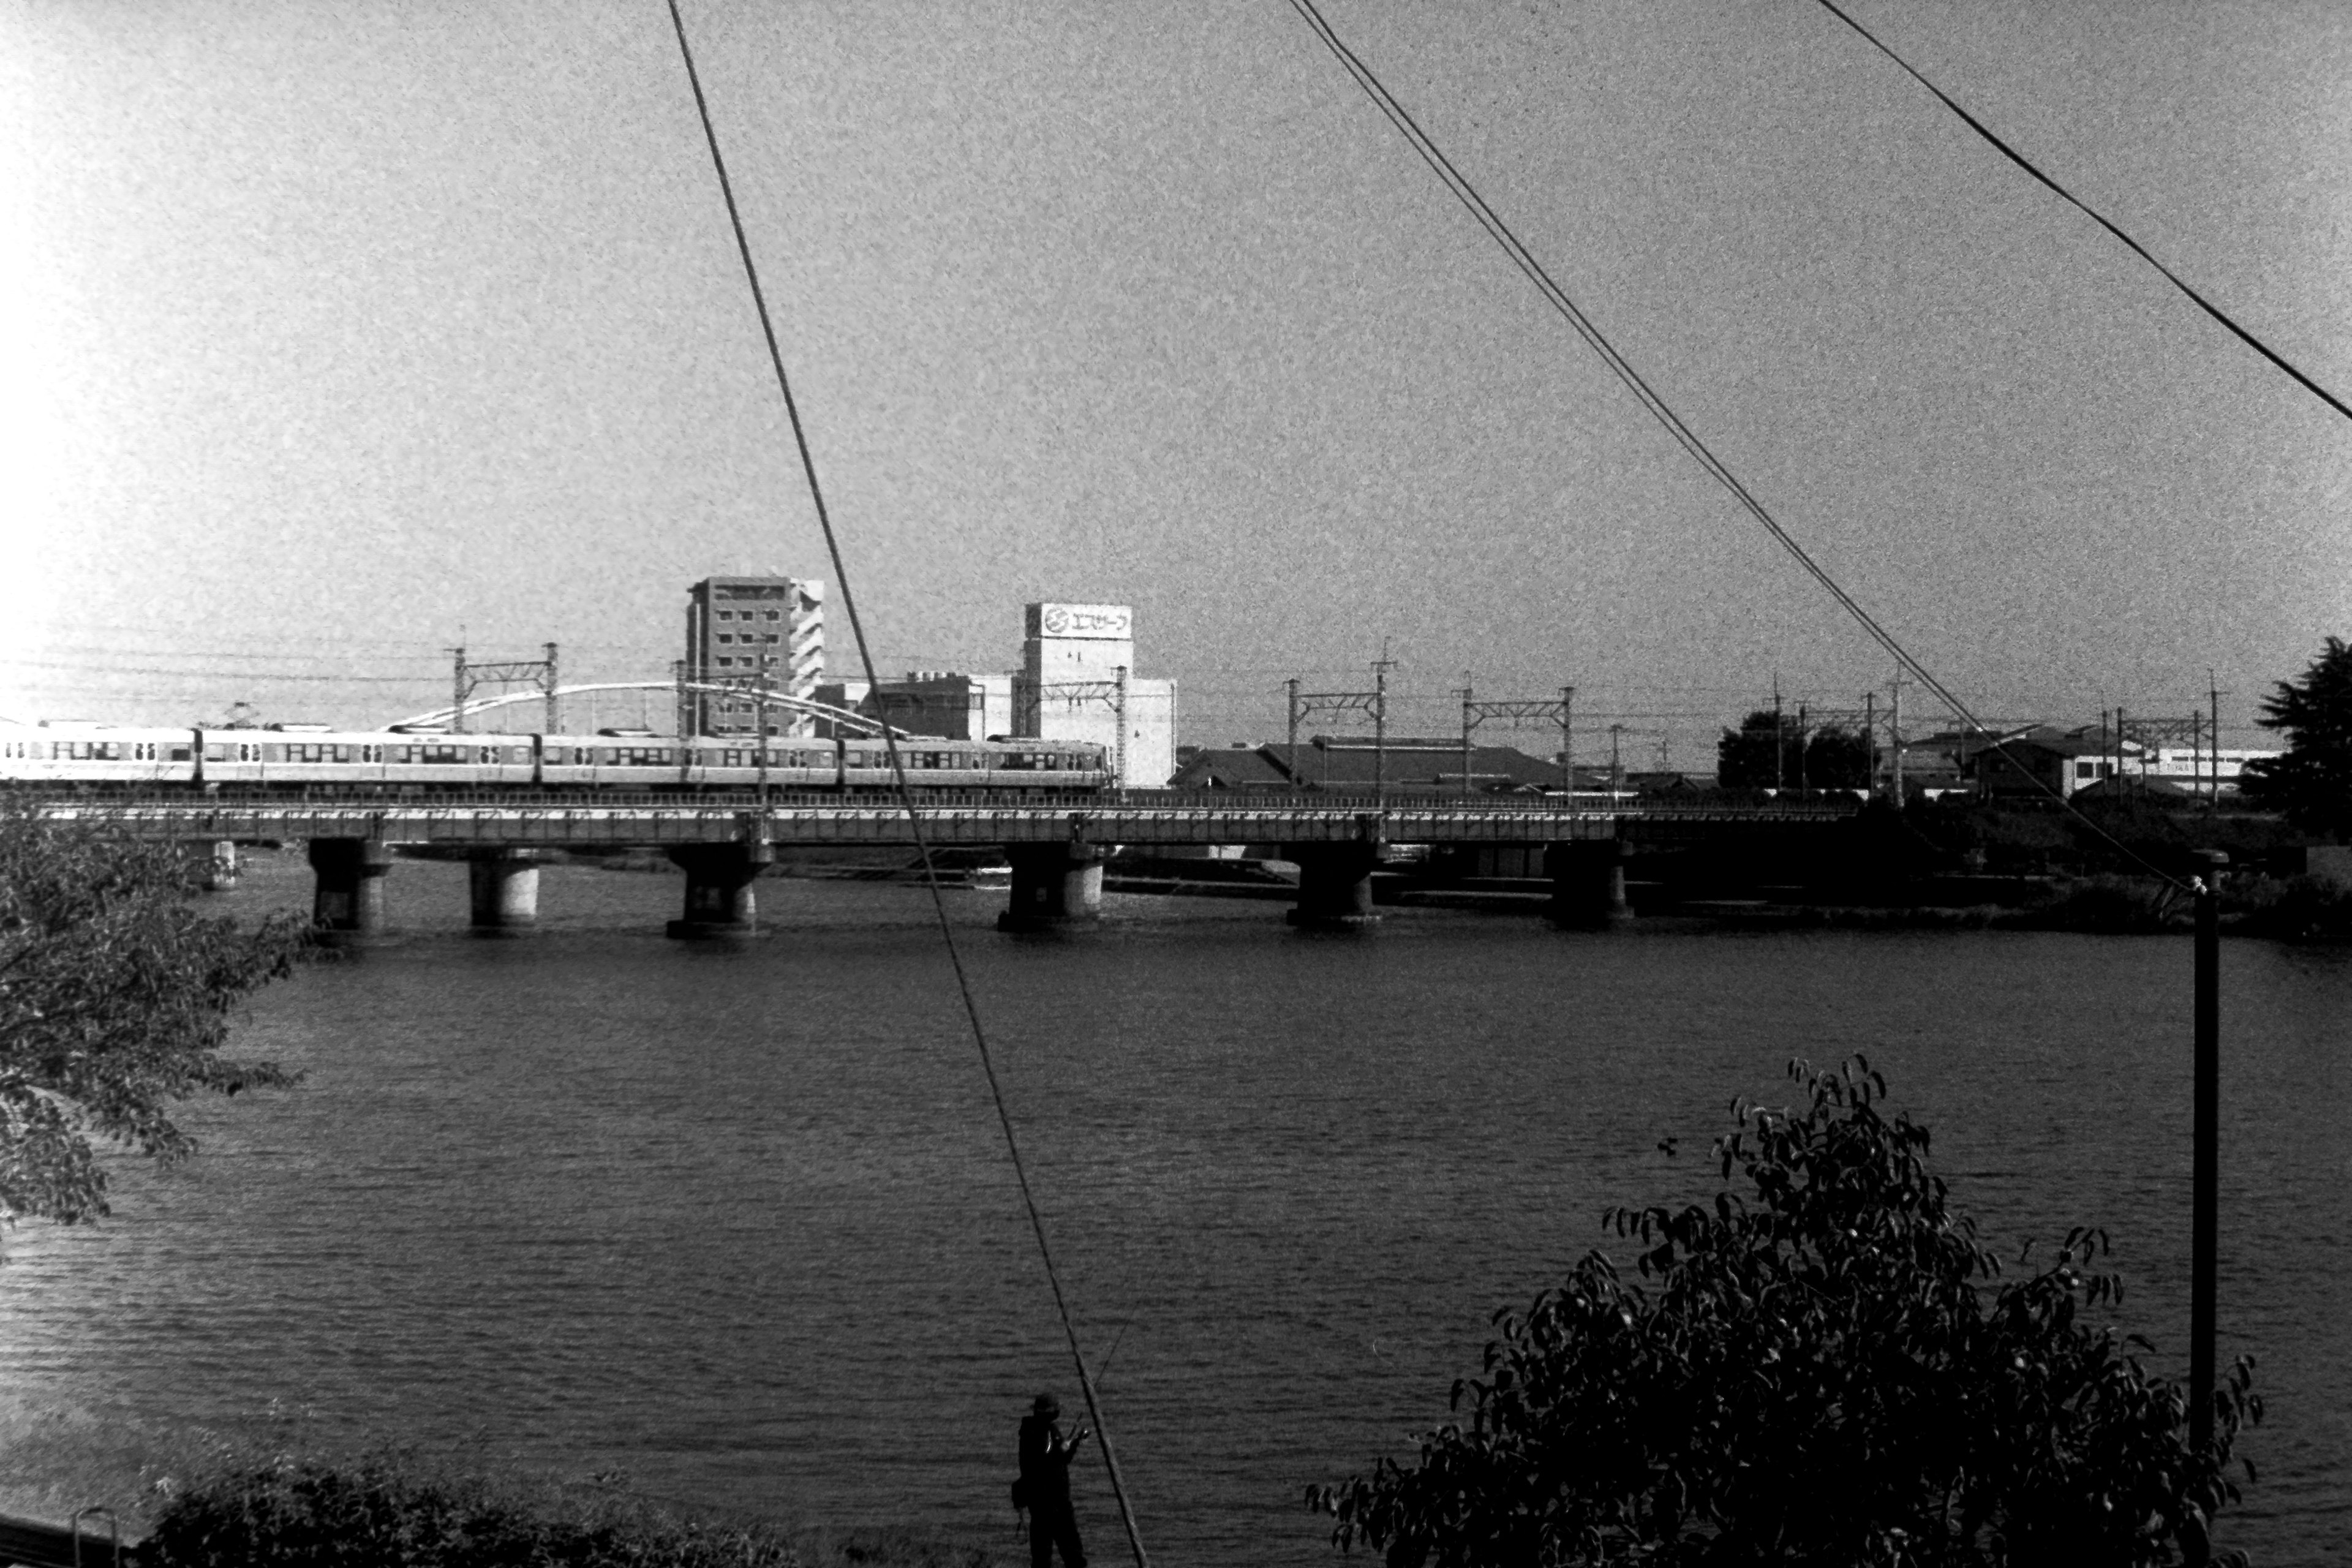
[0,0,2352,766]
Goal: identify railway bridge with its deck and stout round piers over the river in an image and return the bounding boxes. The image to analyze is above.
[42,790,1853,938]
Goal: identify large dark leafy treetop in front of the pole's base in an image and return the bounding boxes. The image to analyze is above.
[1308,1058,2260,1568]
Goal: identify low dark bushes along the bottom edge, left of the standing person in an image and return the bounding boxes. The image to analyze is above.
[141,1450,1011,1568]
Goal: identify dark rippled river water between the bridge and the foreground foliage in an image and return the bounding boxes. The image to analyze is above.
[0,856,2352,1563]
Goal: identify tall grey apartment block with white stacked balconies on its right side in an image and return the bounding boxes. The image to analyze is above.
[684,576,826,736]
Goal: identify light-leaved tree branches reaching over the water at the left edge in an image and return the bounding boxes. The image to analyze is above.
[0,806,306,1225]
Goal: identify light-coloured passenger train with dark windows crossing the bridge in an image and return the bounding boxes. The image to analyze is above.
[0,724,1112,794]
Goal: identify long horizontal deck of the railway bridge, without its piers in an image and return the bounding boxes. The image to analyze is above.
[40,790,1853,846]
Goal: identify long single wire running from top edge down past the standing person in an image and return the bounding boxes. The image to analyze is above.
[668,0,1148,1568]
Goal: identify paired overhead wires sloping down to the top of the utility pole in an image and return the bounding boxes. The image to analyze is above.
[1289,0,2187,891]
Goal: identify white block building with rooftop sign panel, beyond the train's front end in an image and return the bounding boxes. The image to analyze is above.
[1011,604,1176,788]
